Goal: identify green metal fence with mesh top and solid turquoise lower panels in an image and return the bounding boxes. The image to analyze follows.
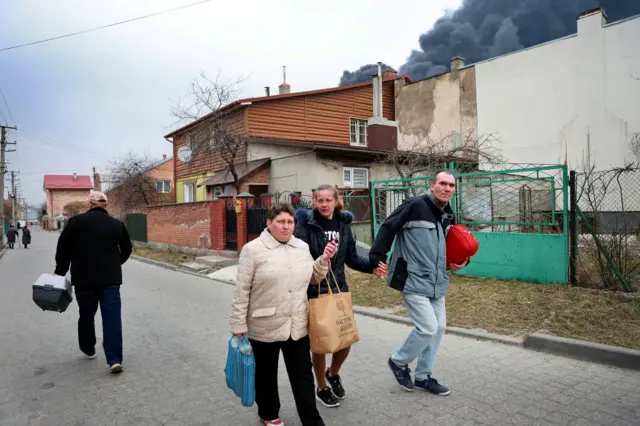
[371,163,569,283]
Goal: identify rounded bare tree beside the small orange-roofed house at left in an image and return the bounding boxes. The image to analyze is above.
[102,152,156,211]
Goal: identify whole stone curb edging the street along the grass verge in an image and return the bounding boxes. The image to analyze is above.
[131,256,640,370]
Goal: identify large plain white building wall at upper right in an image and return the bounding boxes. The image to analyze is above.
[475,11,640,170]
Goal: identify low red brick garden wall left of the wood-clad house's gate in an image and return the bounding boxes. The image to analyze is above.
[146,201,216,249]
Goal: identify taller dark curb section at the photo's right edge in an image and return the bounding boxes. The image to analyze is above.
[523,333,640,370]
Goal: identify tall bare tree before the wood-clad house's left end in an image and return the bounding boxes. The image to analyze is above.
[171,72,247,192]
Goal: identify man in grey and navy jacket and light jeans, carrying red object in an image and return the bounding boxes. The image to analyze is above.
[369,171,469,395]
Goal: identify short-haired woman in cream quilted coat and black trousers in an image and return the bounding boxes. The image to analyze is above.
[231,204,336,426]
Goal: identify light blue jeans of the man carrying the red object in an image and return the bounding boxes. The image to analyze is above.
[391,293,447,380]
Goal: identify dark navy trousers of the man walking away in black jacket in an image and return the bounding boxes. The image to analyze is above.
[76,286,122,365]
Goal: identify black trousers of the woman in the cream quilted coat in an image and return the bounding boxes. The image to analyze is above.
[250,336,324,426]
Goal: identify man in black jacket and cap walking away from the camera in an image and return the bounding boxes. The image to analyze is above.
[55,191,132,373]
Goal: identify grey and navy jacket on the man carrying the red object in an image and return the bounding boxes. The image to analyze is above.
[369,194,455,299]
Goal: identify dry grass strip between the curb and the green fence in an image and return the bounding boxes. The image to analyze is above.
[348,270,640,349]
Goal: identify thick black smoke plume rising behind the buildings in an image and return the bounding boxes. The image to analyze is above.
[340,0,640,86]
